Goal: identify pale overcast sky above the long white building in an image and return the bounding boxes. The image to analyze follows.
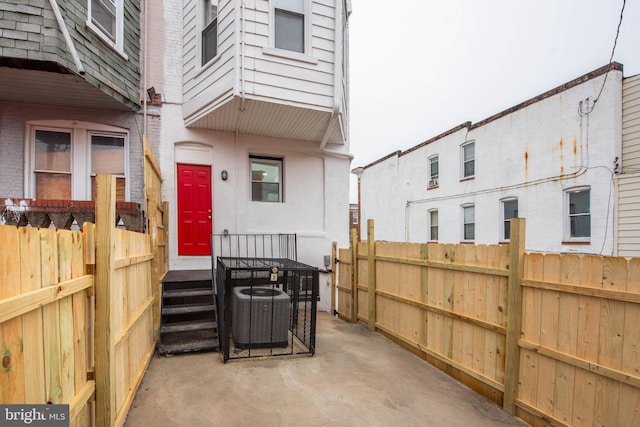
[349,0,640,203]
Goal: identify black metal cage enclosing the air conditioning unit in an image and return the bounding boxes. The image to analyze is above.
[216,257,319,362]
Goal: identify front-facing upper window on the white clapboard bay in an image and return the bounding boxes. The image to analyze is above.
[274,0,306,53]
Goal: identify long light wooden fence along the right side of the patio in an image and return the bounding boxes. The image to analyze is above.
[337,219,640,426]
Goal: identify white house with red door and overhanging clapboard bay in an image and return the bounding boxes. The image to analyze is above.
[147,0,352,310]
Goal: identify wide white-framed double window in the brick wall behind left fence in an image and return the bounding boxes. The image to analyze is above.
[26,121,128,200]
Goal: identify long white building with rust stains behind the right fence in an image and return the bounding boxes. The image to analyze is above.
[360,63,623,255]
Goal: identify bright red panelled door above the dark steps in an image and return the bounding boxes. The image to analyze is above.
[178,164,212,255]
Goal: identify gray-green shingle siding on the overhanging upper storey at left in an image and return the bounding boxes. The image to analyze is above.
[0,0,140,107]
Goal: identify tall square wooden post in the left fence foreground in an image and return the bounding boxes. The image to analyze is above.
[94,174,117,427]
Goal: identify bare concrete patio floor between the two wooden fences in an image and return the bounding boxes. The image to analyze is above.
[125,313,526,427]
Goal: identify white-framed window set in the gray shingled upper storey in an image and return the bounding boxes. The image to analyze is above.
[87,0,124,53]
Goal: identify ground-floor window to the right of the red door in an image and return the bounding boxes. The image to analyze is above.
[250,156,283,202]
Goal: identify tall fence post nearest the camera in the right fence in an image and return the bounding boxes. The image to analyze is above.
[502,218,526,415]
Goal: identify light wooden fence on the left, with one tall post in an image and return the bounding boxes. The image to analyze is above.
[0,175,165,426]
